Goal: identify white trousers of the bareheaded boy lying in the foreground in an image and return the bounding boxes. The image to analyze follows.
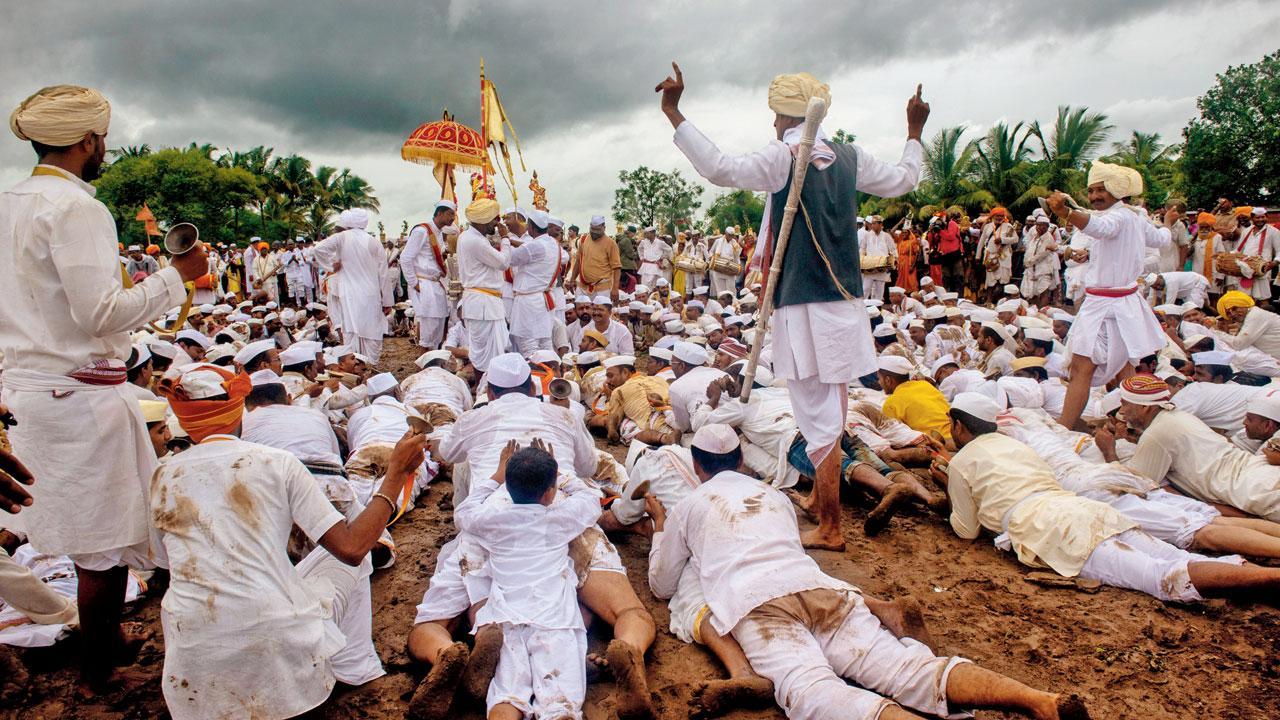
[485,623,586,719]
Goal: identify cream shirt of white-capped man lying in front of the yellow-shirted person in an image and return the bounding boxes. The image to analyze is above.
[947,433,1138,577]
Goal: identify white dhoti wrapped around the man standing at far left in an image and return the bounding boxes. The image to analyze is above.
[0,369,156,561]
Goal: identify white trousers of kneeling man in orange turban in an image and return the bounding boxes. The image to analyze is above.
[297,547,387,685]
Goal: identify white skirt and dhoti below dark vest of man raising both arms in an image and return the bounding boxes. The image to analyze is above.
[771,297,876,468]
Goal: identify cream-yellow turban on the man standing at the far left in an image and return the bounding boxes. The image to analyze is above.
[9,85,111,147]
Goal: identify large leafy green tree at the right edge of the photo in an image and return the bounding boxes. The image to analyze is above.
[1181,50,1280,208]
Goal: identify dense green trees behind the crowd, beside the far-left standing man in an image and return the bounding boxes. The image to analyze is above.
[96,142,379,245]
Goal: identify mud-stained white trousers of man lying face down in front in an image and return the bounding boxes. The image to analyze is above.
[733,588,968,720]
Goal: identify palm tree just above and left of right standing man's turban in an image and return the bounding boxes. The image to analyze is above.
[1028,105,1115,196]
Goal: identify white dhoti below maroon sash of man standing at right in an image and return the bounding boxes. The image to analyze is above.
[1066,292,1169,387]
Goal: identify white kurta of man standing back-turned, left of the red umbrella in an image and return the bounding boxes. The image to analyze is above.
[316,229,394,361]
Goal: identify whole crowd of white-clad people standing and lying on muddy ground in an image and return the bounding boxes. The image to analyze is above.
[0,67,1280,720]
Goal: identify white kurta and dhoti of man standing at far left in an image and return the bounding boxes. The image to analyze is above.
[0,165,186,555]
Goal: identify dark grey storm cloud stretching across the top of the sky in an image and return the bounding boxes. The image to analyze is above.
[0,0,1197,149]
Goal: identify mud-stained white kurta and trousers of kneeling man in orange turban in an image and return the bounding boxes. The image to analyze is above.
[151,436,383,720]
